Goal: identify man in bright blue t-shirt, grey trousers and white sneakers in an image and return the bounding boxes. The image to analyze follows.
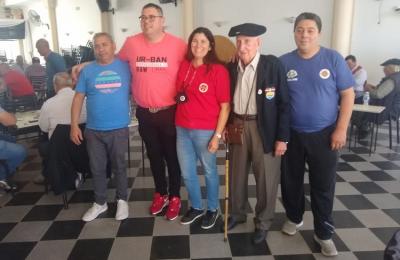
[70,33,131,221]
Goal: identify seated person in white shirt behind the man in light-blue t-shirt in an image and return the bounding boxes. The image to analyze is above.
[34,72,86,184]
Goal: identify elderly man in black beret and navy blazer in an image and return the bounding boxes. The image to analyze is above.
[228,23,289,244]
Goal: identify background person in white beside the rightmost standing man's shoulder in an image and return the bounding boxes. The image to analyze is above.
[345,55,367,104]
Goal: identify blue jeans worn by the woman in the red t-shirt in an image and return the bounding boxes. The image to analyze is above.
[176,126,219,211]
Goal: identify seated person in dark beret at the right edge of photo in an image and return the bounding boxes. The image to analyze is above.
[352,59,400,139]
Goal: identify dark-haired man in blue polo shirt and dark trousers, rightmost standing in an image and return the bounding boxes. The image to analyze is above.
[281,13,354,256]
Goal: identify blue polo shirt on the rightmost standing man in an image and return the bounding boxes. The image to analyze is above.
[280,47,354,133]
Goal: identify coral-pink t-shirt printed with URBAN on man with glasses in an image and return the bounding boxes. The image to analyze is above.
[118,33,186,108]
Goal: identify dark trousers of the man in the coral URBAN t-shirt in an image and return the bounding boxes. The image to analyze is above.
[136,107,181,197]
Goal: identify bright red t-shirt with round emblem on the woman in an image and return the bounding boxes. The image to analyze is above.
[175,60,231,130]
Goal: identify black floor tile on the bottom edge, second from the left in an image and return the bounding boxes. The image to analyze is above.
[68,238,114,260]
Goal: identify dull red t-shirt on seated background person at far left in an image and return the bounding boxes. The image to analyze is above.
[3,70,34,97]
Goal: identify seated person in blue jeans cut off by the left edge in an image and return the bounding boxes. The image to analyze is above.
[0,103,26,191]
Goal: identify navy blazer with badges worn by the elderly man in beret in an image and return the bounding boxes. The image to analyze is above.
[228,55,290,153]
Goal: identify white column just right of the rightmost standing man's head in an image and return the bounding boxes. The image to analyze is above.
[331,0,354,56]
